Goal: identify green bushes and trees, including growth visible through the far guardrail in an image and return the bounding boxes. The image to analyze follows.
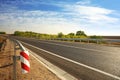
[14,31,103,44]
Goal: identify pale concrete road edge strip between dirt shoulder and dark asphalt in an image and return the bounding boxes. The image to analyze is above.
[26,48,78,80]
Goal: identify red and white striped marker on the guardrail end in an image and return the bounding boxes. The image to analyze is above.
[20,51,30,74]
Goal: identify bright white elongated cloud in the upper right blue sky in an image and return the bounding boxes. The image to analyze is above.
[64,4,119,23]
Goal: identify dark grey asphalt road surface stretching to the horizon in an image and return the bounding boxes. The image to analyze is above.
[13,37,120,80]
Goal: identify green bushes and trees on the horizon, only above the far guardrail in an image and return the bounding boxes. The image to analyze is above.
[14,31,100,39]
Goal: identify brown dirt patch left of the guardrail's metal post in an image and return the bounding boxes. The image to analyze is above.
[0,40,13,80]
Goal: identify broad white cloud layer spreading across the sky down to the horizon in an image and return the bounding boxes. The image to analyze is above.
[0,0,120,35]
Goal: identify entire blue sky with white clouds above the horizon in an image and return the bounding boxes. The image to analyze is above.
[0,0,120,36]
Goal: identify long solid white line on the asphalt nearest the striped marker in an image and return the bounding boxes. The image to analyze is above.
[21,41,120,80]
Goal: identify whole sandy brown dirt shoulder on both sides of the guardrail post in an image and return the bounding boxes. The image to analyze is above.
[0,40,60,80]
